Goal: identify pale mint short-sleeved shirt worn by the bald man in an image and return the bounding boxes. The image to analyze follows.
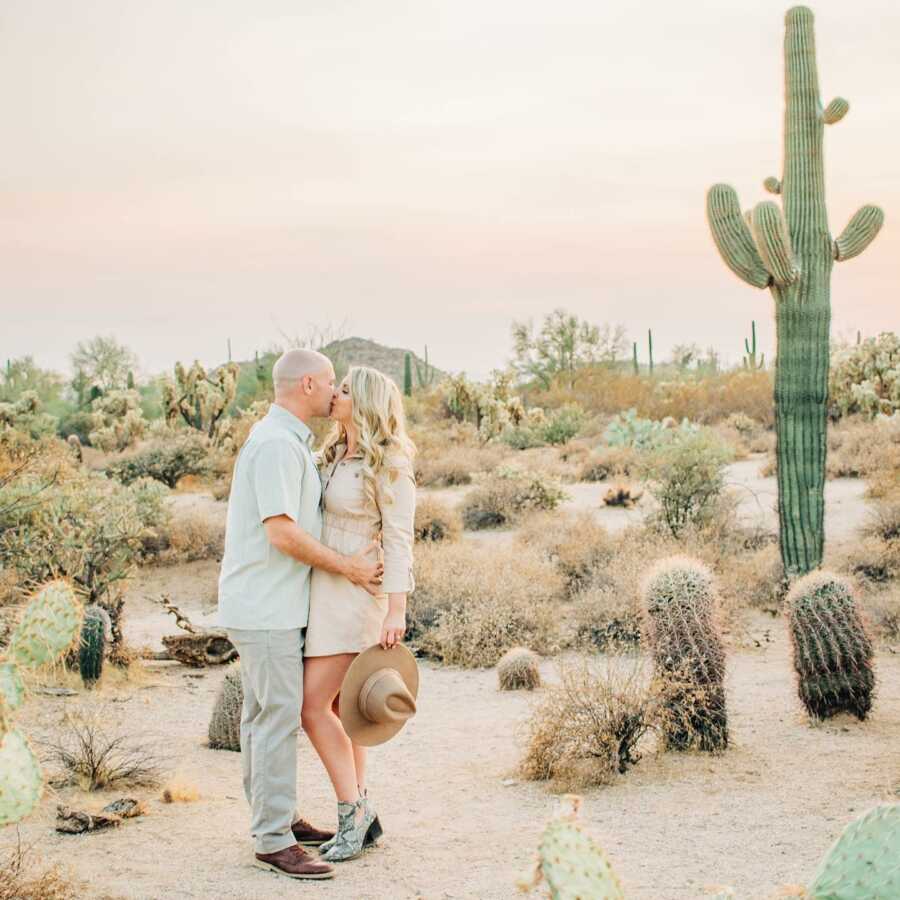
[217,403,322,630]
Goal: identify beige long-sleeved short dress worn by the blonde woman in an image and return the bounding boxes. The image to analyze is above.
[304,448,416,656]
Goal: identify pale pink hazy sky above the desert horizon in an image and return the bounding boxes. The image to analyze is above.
[0,0,900,376]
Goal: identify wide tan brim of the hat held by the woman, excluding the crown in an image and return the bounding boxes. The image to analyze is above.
[338,644,419,747]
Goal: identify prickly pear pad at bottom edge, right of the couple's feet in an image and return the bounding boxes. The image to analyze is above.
[519,795,625,900]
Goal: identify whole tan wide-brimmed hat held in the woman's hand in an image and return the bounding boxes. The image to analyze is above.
[338,644,419,747]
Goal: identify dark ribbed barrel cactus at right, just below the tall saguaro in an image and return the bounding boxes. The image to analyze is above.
[786,571,875,719]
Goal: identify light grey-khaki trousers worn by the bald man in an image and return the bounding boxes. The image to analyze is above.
[228,628,305,853]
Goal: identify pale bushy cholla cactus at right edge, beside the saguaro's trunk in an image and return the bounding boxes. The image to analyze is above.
[828,331,900,418]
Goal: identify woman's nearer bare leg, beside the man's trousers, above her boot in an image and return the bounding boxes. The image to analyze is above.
[300,653,359,803]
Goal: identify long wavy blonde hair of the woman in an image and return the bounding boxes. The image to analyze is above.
[319,366,416,508]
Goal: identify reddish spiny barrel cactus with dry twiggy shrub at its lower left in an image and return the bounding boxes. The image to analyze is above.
[641,556,728,751]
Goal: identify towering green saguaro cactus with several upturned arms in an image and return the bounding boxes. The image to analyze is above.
[707,6,884,575]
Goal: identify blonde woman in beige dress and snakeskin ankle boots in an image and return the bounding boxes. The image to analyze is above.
[302,366,416,862]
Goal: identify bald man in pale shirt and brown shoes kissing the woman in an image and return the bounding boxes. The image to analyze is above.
[218,350,383,879]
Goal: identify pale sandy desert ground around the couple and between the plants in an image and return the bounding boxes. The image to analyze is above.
[0,460,888,900]
